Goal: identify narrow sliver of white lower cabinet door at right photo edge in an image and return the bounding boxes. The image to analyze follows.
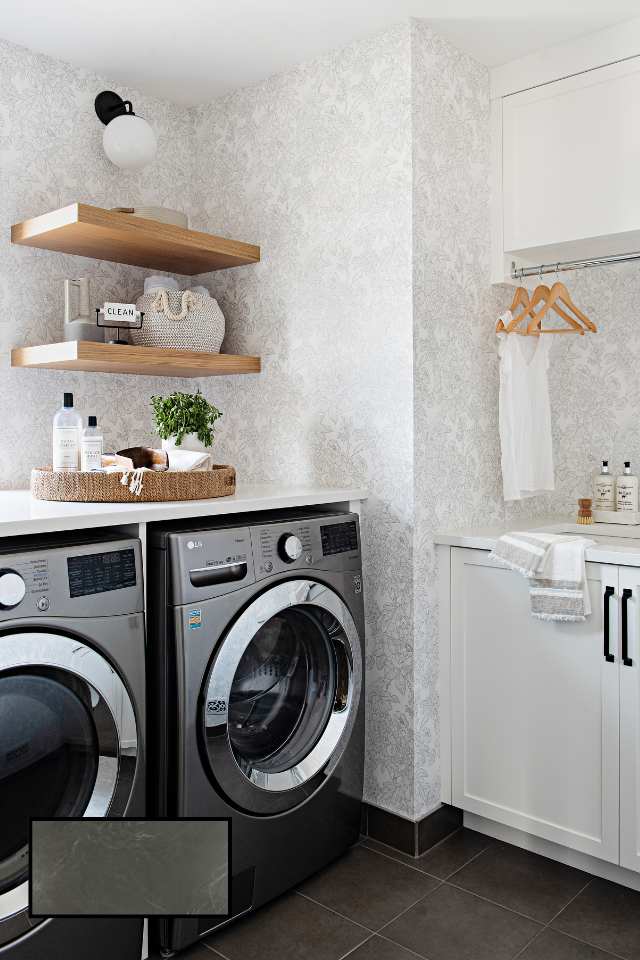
[619,567,640,872]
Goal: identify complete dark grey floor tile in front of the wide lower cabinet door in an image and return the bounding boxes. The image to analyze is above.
[450,843,590,923]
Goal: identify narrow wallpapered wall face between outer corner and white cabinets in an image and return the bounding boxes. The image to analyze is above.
[412,20,504,820]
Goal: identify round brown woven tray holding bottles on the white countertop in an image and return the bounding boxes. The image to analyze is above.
[31,465,236,503]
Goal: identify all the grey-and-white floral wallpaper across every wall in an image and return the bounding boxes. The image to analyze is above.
[0,21,572,819]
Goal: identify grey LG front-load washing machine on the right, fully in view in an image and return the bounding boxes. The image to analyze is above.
[148,511,364,954]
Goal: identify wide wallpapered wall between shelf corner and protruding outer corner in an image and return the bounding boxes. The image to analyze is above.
[196,24,414,817]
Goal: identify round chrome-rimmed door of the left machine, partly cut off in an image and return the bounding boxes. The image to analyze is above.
[0,632,137,946]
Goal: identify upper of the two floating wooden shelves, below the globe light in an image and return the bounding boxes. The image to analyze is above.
[11,203,260,276]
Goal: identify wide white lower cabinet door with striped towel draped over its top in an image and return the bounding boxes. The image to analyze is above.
[451,549,619,863]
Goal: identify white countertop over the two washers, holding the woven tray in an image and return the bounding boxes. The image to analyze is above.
[0,483,367,537]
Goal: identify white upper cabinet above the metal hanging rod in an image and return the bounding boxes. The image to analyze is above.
[492,56,640,282]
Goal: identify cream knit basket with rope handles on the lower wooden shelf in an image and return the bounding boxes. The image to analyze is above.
[129,289,224,353]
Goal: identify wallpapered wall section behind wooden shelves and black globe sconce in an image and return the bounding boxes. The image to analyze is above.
[0,40,194,489]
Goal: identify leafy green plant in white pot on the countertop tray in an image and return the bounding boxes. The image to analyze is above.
[151,390,222,450]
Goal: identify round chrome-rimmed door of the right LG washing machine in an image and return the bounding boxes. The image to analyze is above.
[201,580,362,814]
